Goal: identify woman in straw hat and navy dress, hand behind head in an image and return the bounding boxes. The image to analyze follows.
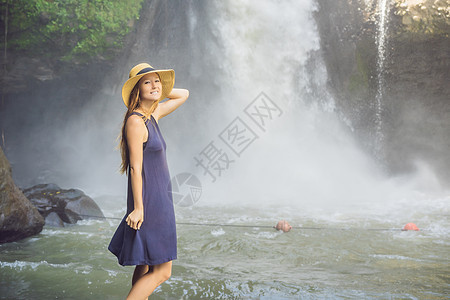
[108,63,189,299]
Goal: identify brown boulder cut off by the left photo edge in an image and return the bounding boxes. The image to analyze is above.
[0,148,44,243]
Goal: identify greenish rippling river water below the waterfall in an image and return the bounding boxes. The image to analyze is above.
[0,193,450,299]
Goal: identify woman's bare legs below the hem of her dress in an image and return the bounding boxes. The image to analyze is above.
[127,261,172,300]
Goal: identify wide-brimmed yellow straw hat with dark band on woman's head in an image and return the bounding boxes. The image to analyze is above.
[122,63,175,107]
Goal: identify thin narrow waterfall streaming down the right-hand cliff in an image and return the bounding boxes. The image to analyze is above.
[375,0,389,161]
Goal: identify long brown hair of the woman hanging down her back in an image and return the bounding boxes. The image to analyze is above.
[119,75,159,174]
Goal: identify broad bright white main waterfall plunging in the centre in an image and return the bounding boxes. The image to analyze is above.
[188,0,396,209]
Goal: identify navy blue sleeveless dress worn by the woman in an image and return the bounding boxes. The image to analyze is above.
[108,112,177,266]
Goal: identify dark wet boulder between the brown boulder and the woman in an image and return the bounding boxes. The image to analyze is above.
[23,184,105,227]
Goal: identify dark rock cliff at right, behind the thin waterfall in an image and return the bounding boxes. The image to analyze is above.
[316,0,450,183]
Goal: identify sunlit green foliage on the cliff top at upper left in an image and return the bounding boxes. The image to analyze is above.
[0,0,144,61]
